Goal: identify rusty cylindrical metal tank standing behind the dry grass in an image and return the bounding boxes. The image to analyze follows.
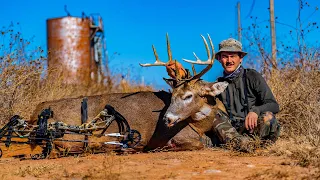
[47,16,92,84]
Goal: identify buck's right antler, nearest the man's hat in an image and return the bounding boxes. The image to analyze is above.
[183,34,215,80]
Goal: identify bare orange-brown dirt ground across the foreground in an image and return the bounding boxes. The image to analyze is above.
[0,148,320,180]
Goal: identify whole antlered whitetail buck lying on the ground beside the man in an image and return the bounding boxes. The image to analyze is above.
[31,36,227,151]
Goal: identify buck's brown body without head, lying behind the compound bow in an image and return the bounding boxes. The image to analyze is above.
[30,91,210,151]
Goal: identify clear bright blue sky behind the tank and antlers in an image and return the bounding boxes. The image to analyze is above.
[0,0,320,88]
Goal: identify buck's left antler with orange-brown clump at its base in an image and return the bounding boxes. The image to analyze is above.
[139,33,187,80]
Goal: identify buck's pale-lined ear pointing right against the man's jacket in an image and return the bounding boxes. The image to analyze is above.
[201,82,229,96]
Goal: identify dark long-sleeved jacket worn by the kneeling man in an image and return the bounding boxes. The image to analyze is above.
[218,66,279,119]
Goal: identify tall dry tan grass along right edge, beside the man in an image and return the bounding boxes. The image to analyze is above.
[268,59,320,166]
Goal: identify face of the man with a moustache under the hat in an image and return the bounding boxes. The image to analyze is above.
[219,52,242,74]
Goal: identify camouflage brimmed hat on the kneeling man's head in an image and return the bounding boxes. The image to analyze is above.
[215,38,247,59]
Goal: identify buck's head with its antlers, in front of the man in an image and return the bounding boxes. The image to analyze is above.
[140,35,228,127]
